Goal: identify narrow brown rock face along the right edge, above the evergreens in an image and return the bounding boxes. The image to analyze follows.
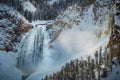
[109,1,120,58]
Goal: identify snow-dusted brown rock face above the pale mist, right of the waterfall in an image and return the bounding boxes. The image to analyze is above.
[47,0,114,43]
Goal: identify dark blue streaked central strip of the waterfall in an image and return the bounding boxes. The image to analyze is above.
[31,27,44,63]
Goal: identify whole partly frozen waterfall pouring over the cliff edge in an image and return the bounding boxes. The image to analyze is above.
[17,21,49,73]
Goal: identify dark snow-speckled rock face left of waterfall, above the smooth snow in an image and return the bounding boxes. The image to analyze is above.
[0,5,32,51]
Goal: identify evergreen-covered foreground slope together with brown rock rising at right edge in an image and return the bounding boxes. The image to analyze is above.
[42,1,120,80]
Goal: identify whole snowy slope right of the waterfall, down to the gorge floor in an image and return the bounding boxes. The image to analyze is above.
[26,0,114,80]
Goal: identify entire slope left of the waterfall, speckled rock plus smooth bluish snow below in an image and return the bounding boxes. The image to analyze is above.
[0,4,32,80]
